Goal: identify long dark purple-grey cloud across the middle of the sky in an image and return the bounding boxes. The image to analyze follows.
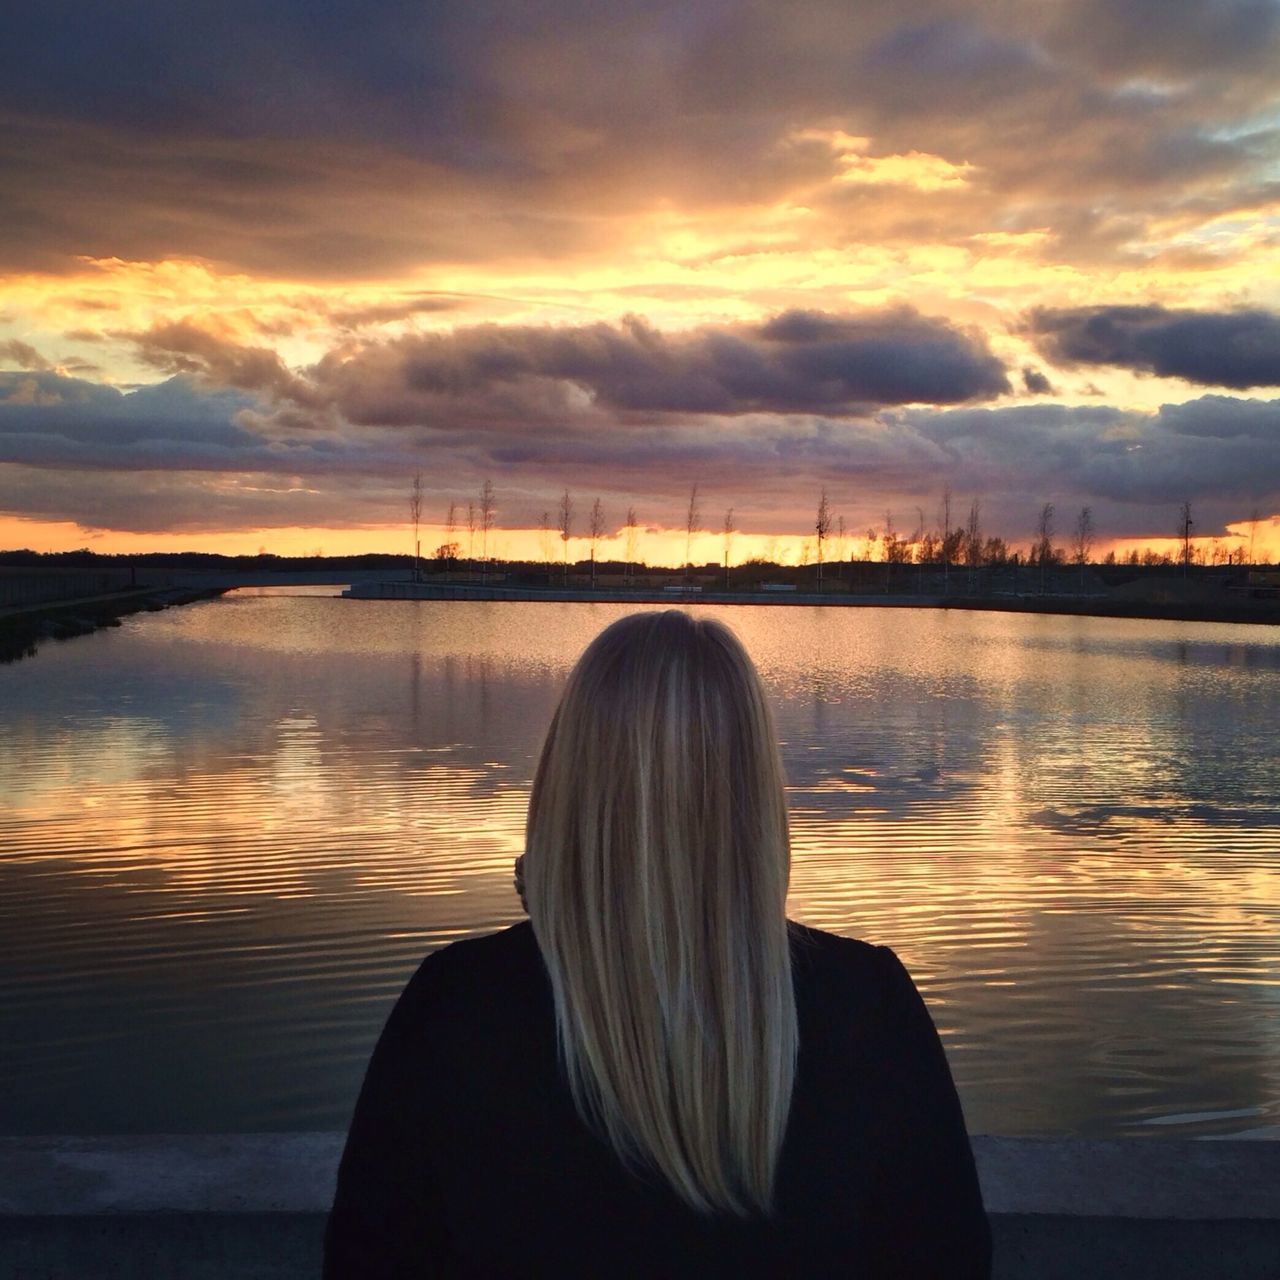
[227,307,1009,429]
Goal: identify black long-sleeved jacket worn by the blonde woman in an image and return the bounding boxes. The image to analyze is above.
[324,922,991,1280]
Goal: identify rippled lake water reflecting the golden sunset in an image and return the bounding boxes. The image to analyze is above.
[0,591,1280,1137]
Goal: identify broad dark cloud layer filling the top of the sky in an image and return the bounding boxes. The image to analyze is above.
[0,0,1277,278]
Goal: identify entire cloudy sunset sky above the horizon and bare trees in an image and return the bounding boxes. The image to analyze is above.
[0,0,1280,559]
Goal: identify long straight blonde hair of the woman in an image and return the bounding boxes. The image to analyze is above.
[524,609,796,1216]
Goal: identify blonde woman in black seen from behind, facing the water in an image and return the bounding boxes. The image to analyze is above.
[325,611,991,1280]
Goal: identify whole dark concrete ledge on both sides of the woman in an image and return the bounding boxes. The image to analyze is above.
[0,1133,1280,1280]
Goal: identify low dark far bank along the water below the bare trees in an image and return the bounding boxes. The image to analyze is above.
[342,580,1280,625]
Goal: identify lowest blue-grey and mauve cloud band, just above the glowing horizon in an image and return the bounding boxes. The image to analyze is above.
[0,372,1280,541]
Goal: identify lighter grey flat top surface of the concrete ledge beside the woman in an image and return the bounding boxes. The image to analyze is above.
[0,1133,1280,1222]
